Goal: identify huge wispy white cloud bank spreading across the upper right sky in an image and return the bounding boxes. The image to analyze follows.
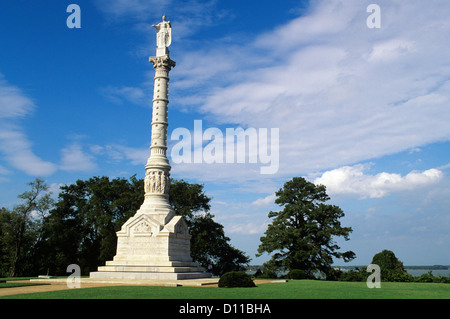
[174,0,450,178]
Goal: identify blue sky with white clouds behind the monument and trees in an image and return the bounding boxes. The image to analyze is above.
[0,0,450,265]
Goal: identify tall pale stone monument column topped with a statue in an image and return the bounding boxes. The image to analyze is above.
[90,16,211,280]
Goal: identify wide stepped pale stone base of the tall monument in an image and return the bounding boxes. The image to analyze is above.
[90,212,211,280]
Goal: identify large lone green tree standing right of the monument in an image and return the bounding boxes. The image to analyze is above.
[258,177,355,276]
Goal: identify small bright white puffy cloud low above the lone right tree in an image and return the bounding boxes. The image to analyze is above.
[314,164,443,198]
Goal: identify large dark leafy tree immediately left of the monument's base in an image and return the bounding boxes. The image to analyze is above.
[42,176,144,274]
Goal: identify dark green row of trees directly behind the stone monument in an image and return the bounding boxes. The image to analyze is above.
[0,176,250,277]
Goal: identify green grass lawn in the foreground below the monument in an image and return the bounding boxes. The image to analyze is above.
[3,280,450,299]
